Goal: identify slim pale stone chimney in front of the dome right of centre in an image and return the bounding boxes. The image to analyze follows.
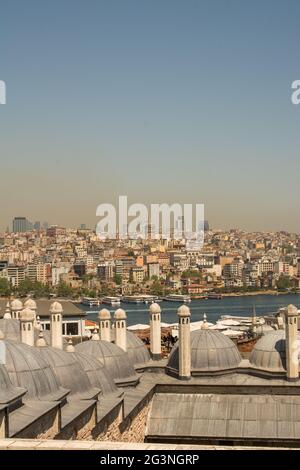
[178,305,191,380]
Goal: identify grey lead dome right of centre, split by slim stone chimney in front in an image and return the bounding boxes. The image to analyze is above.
[167,329,241,373]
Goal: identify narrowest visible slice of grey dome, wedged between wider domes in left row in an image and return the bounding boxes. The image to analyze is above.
[69,352,118,395]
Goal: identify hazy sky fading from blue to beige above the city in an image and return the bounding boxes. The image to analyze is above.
[0,0,300,232]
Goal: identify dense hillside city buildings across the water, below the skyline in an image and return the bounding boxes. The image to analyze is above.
[0,217,300,298]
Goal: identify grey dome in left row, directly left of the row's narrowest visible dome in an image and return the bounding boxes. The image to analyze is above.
[36,346,100,398]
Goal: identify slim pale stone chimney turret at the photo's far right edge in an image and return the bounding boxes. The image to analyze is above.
[284,305,299,382]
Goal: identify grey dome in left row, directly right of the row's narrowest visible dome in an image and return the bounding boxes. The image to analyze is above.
[75,340,138,385]
